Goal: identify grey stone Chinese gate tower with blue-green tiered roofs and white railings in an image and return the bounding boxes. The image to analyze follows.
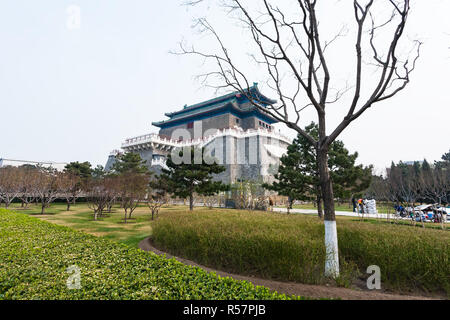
[105,83,292,183]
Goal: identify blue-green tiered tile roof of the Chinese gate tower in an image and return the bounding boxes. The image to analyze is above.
[152,83,277,128]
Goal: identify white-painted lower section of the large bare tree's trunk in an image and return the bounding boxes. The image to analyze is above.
[324,220,339,278]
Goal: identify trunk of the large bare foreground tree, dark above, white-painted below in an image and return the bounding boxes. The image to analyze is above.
[317,148,339,278]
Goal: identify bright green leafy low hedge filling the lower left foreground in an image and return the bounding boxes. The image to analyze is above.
[0,209,295,299]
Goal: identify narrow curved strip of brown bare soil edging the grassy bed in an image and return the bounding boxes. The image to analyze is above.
[139,238,443,300]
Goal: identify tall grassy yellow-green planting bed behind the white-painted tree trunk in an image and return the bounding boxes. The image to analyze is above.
[152,209,450,295]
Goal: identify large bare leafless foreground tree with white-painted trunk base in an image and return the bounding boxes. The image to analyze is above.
[178,0,421,277]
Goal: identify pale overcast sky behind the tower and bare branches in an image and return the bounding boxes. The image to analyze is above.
[0,0,450,172]
